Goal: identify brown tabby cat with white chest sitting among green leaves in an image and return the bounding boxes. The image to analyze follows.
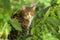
[12,6,36,36]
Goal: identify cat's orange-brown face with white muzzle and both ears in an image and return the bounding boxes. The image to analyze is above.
[22,6,35,19]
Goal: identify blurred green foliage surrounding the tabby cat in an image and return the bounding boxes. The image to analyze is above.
[0,0,60,40]
